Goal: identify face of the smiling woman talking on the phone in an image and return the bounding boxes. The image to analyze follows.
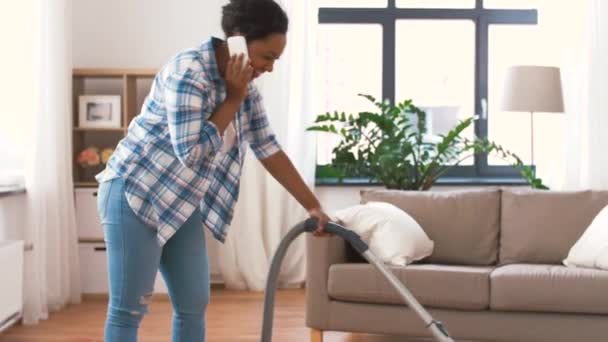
[247,33,287,78]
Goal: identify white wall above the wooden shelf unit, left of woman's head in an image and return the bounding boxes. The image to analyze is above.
[72,0,227,68]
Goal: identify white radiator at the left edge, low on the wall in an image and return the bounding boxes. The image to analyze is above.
[0,241,23,332]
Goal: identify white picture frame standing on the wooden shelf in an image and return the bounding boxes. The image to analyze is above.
[78,95,122,128]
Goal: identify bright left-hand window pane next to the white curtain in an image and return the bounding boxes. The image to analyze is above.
[316,24,382,165]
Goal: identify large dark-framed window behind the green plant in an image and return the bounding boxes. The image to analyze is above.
[317,0,538,178]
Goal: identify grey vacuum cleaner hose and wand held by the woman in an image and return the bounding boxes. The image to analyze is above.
[262,218,454,342]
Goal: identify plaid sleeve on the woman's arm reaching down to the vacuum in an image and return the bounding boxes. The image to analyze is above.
[248,87,281,160]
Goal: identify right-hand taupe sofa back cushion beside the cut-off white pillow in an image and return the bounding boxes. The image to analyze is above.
[496,189,608,265]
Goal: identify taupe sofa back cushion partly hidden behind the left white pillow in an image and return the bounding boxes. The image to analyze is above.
[361,188,500,265]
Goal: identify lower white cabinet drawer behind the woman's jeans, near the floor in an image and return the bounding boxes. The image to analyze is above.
[78,242,167,294]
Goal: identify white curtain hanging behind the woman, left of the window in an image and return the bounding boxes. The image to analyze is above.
[216,0,317,290]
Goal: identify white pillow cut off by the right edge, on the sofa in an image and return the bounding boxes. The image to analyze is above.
[564,206,608,270]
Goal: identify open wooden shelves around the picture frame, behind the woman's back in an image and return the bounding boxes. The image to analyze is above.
[72,68,157,187]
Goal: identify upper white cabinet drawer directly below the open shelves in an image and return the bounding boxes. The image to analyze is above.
[74,188,103,239]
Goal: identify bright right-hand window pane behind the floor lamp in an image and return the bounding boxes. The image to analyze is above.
[488,25,563,167]
